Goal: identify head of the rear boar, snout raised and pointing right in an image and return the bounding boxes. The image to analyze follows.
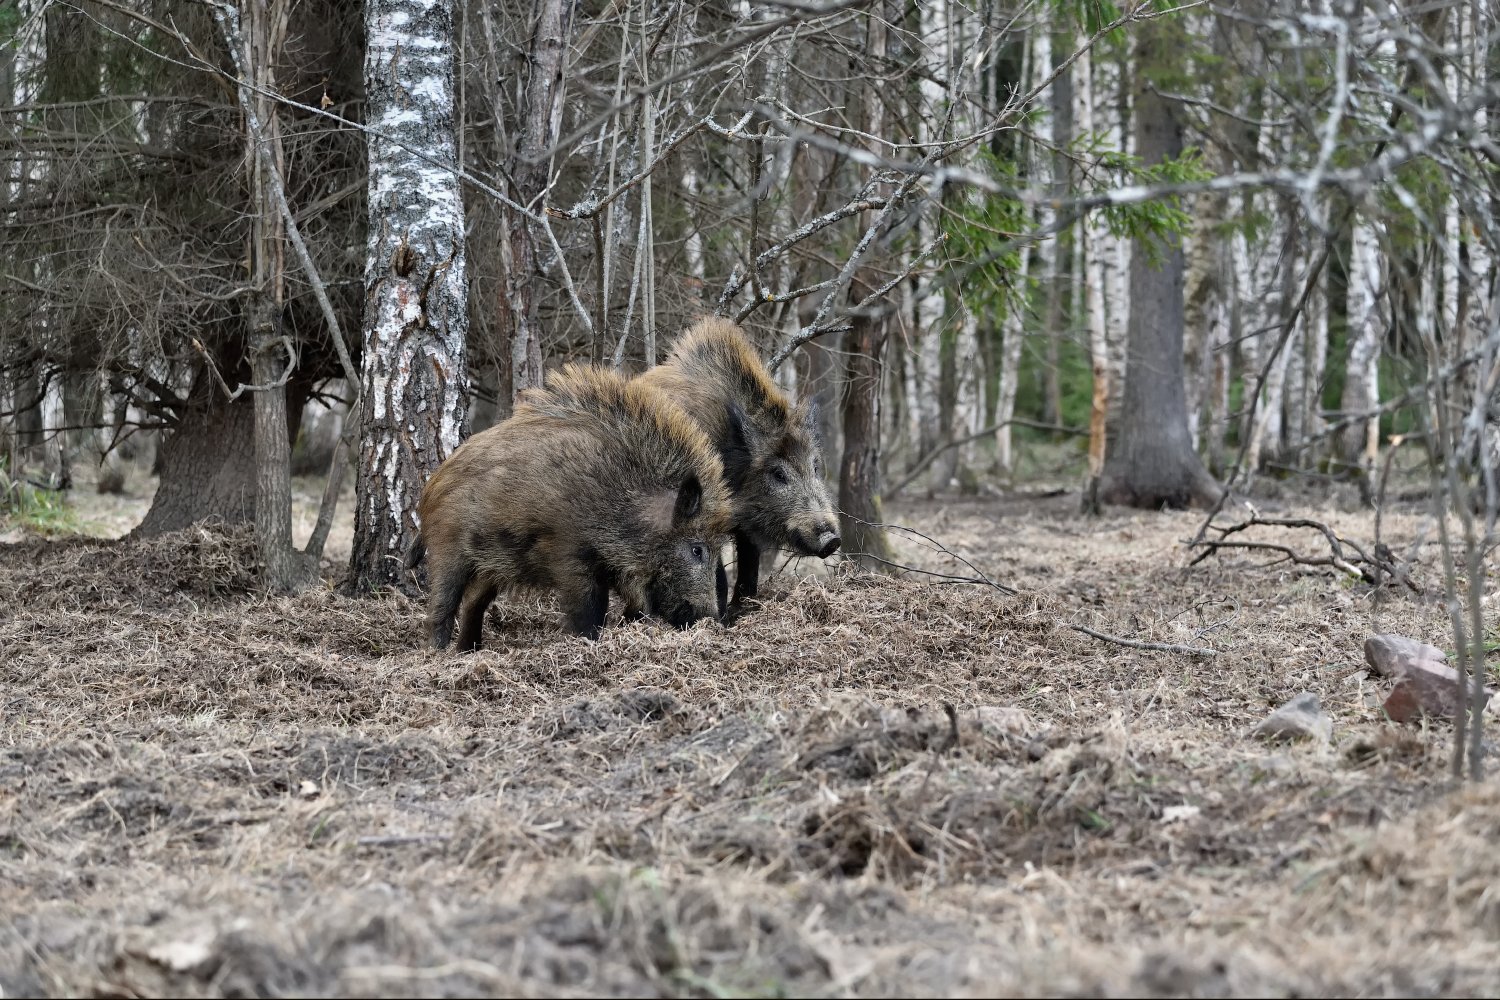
[725,405,840,559]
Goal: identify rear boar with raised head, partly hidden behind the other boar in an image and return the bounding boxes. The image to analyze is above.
[636,318,839,606]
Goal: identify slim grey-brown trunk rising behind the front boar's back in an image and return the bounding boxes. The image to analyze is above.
[497,0,573,402]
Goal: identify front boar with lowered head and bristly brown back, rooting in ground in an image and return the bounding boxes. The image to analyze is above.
[408,366,731,651]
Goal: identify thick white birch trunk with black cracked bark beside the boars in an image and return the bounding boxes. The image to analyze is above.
[347,0,468,591]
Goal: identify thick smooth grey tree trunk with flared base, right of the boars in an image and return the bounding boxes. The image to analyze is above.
[1098,22,1220,508]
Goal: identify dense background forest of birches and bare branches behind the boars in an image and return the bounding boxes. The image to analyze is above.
[0,0,1497,563]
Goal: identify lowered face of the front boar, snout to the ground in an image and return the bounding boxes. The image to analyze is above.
[645,475,725,628]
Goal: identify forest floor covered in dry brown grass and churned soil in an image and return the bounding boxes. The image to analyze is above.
[0,464,1500,997]
